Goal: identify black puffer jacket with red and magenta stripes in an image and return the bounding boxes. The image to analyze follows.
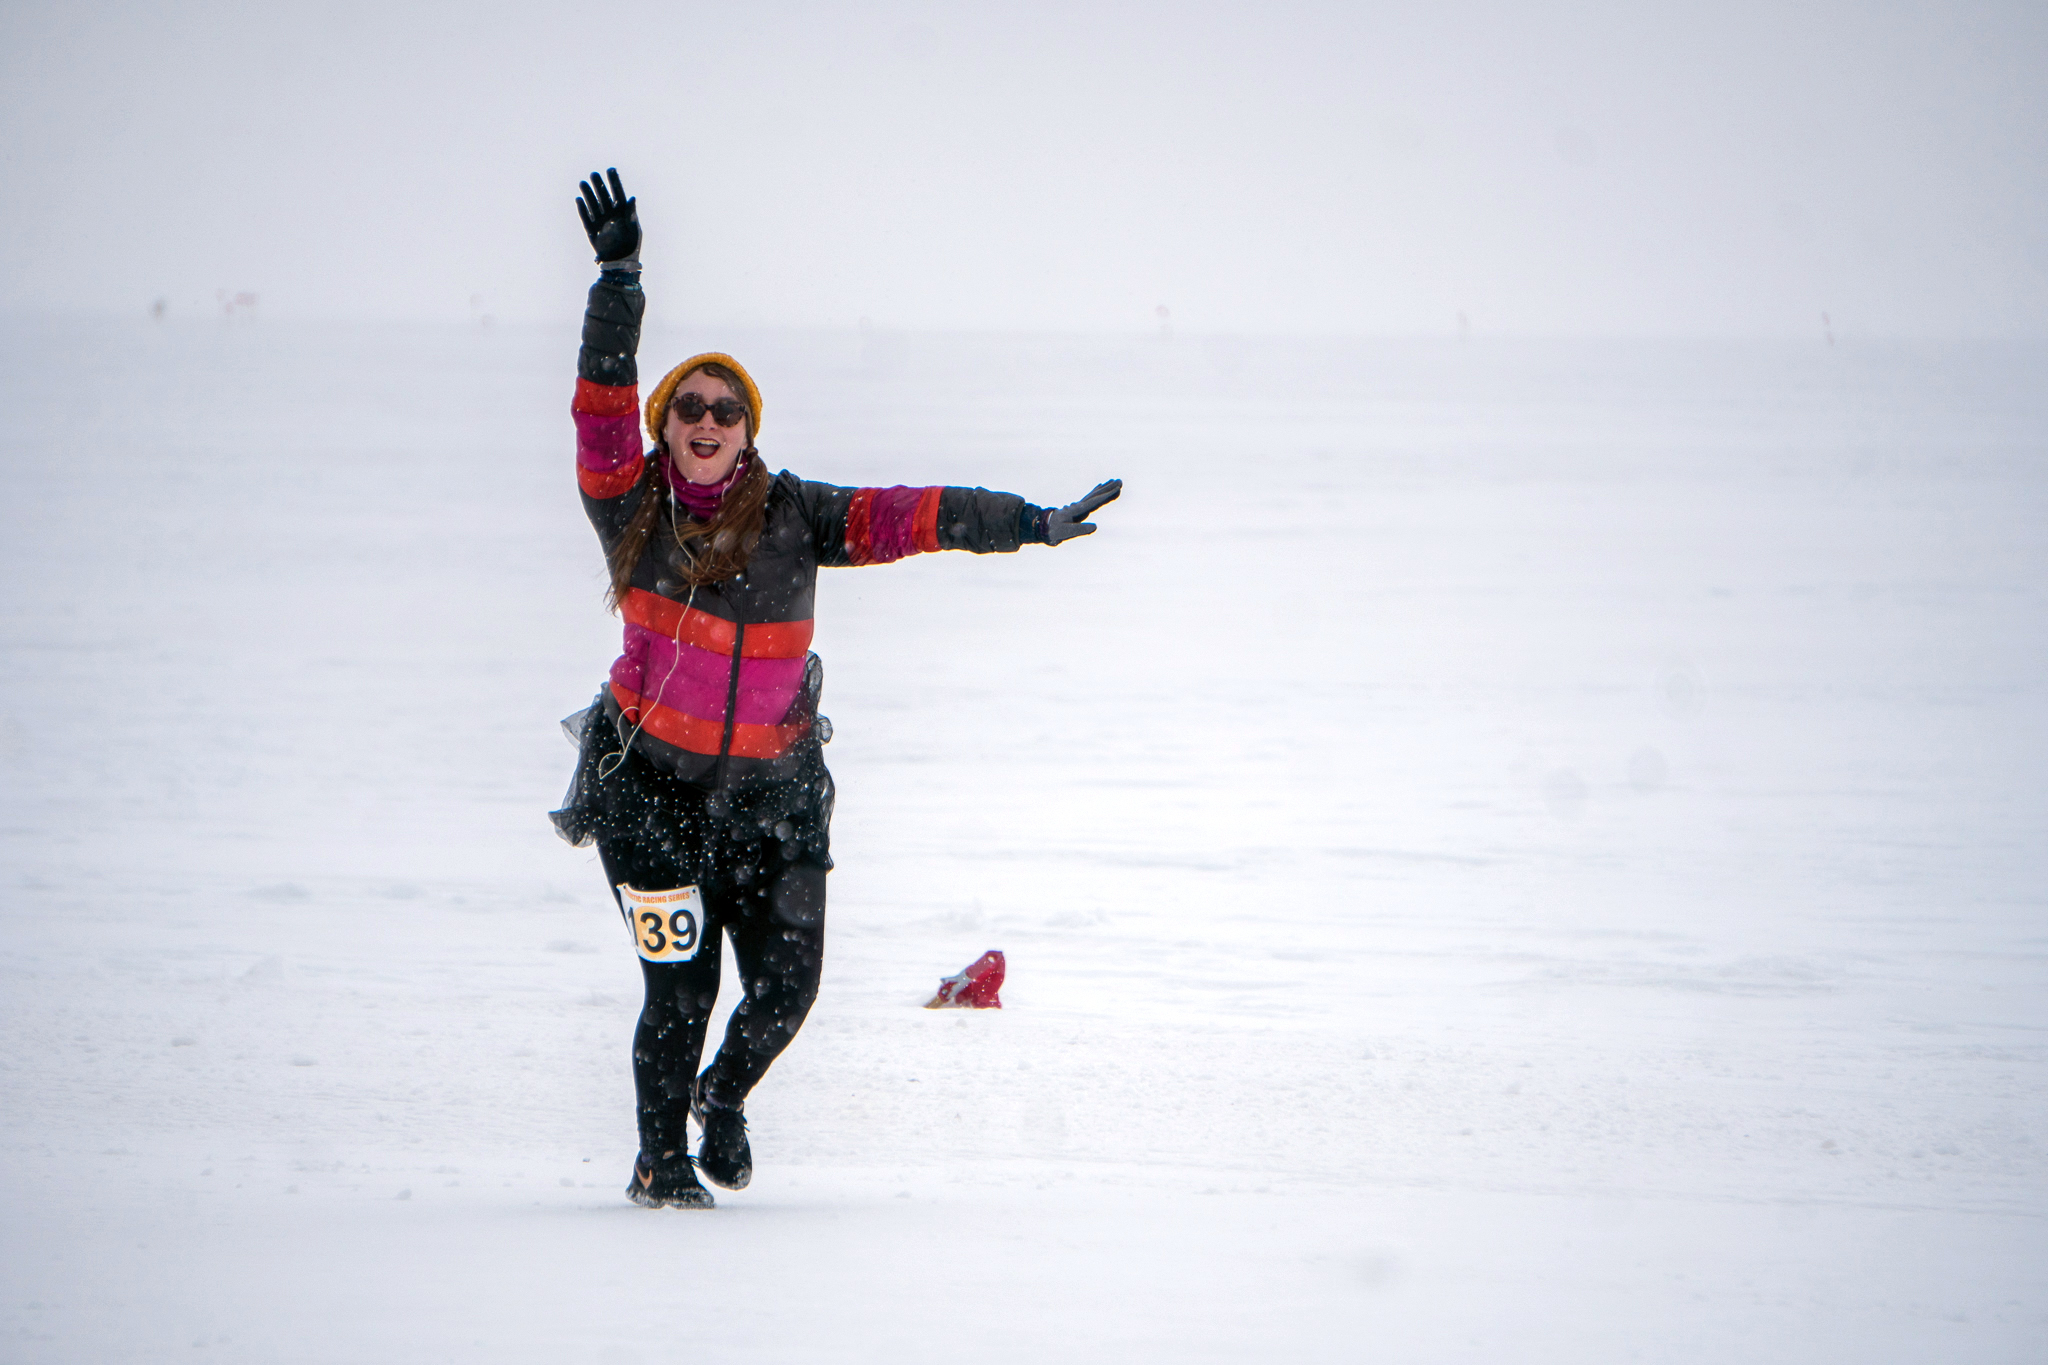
[571,274,1044,788]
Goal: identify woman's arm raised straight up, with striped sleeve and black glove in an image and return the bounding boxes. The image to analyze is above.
[569,170,647,516]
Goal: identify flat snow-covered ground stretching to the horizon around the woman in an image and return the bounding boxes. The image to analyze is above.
[0,315,2048,1365]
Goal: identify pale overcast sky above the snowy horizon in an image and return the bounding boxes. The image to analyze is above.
[0,0,2048,336]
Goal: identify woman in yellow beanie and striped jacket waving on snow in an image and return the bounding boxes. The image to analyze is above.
[553,170,1122,1207]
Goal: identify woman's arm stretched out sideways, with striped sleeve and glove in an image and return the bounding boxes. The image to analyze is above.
[784,475,1124,565]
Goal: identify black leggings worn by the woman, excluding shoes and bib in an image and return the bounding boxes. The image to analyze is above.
[598,839,825,1156]
